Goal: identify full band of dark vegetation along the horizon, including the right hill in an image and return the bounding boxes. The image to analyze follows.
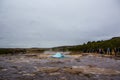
[0,37,120,54]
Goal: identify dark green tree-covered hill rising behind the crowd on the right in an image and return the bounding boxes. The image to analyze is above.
[52,37,120,51]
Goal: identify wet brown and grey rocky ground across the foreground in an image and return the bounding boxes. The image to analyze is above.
[0,54,120,80]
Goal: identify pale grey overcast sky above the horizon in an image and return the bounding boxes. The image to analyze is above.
[0,0,120,48]
